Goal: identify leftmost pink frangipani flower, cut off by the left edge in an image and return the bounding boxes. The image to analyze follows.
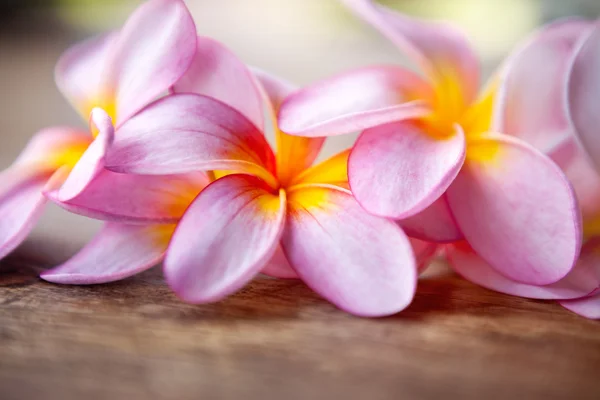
[0,0,196,257]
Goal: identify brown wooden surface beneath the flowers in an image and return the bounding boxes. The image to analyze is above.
[0,261,600,400]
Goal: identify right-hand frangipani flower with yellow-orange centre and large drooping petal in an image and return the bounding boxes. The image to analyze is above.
[279,0,581,285]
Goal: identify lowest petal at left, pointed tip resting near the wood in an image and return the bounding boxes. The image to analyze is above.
[40,223,174,285]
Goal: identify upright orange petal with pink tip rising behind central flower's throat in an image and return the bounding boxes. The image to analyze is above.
[254,69,325,185]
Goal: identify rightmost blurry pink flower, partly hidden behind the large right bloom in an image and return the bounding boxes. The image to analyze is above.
[445,20,600,318]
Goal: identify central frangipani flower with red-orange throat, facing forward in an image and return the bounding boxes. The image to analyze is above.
[106,38,417,316]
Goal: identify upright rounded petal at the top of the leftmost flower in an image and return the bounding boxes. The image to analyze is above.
[100,0,196,126]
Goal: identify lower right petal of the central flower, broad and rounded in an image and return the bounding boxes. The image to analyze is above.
[282,185,417,317]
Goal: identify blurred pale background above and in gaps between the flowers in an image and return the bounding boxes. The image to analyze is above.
[0,0,600,264]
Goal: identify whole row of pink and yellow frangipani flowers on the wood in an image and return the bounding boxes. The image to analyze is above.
[0,0,600,318]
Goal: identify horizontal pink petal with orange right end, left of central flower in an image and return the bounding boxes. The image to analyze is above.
[46,170,209,224]
